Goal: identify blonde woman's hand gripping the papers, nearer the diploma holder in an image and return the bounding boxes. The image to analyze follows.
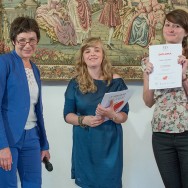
[96,101,116,119]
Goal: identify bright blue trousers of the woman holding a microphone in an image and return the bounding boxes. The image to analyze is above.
[0,128,42,188]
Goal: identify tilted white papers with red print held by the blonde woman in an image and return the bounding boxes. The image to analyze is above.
[101,89,133,121]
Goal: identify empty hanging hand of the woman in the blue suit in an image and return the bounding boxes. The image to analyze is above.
[0,147,12,171]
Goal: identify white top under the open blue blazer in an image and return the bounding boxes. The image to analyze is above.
[25,68,39,130]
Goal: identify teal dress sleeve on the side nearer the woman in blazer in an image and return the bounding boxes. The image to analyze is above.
[63,79,77,119]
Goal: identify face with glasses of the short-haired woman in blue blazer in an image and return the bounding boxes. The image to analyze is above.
[13,31,38,61]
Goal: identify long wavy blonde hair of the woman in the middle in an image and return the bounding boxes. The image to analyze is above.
[75,37,113,94]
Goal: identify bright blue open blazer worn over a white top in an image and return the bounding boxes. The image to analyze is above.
[0,51,49,150]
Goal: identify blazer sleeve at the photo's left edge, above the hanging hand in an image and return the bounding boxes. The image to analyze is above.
[0,57,9,149]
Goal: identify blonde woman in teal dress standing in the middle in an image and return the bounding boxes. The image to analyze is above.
[64,37,129,188]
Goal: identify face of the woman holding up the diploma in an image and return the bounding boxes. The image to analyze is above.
[163,19,187,44]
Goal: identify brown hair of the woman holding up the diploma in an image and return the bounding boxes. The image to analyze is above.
[166,9,188,58]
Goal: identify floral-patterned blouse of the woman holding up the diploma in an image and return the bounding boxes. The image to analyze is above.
[142,59,188,133]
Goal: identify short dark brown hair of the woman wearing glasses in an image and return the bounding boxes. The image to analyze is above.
[10,17,40,42]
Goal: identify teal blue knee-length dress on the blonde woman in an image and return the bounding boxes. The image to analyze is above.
[64,78,129,188]
